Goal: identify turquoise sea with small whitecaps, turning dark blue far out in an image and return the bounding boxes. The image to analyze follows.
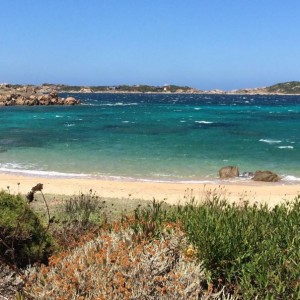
[0,94,300,181]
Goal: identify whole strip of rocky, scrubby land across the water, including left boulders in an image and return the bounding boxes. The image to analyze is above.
[0,81,300,106]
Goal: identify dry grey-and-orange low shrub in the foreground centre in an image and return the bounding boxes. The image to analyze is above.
[25,226,210,300]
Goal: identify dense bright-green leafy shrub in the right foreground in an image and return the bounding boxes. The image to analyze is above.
[176,197,300,299]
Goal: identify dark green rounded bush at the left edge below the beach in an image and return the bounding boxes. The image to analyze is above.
[0,191,53,267]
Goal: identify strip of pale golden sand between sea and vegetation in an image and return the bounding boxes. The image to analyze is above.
[0,174,300,206]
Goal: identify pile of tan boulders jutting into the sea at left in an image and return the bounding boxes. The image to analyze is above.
[0,92,80,106]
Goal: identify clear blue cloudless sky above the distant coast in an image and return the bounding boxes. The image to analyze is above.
[0,0,300,89]
